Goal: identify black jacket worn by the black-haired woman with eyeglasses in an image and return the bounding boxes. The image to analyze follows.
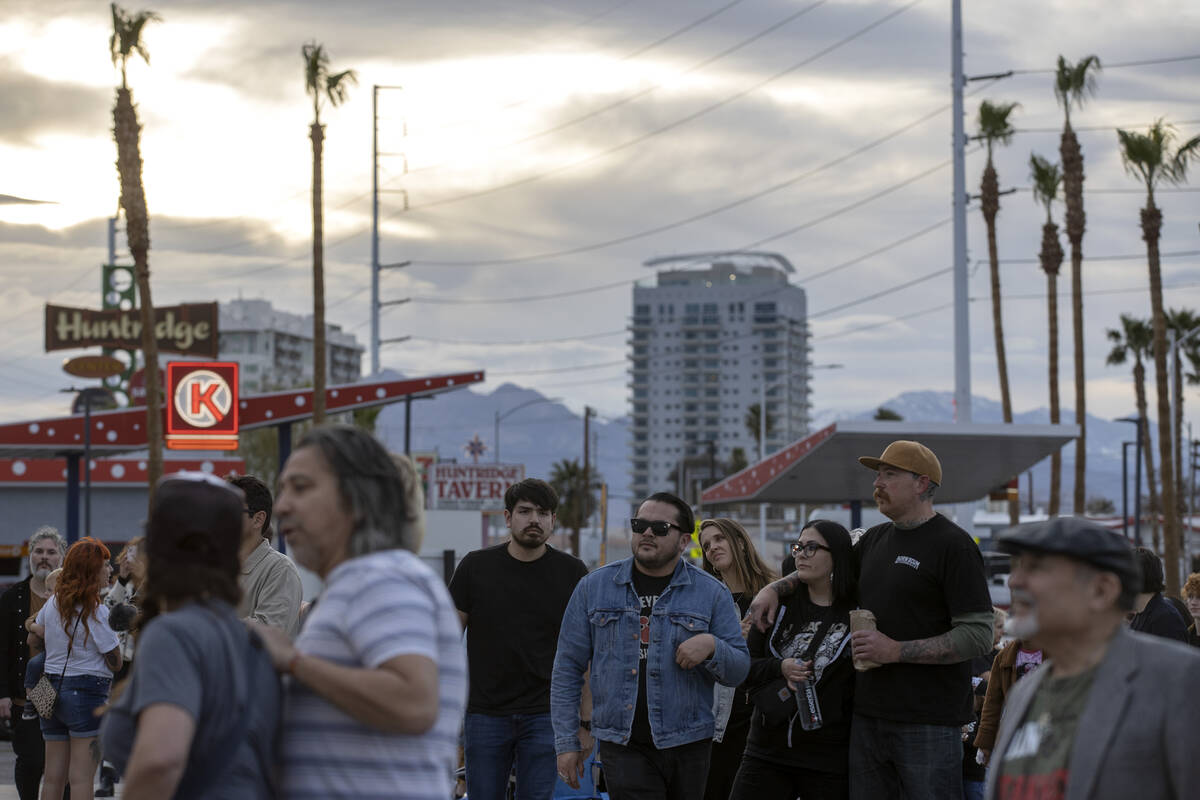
[745,587,854,774]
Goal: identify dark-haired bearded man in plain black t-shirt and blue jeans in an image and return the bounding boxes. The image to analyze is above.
[450,479,590,800]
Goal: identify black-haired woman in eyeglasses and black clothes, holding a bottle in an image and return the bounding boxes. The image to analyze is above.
[730,519,858,800]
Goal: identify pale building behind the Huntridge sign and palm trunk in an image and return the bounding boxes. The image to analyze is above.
[217,300,362,392]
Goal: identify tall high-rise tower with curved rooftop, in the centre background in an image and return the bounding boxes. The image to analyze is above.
[629,252,811,499]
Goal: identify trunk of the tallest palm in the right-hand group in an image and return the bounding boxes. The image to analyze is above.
[1058,125,1087,515]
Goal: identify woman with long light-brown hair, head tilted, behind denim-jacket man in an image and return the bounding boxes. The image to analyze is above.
[700,517,776,800]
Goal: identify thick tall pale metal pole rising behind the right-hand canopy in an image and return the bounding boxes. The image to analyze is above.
[950,0,971,422]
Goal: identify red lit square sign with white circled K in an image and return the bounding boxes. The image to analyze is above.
[167,361,238,450]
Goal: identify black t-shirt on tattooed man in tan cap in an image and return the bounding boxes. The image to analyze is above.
[854,515,991,726]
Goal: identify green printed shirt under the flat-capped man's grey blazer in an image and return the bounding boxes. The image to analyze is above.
[996,667,1096,800]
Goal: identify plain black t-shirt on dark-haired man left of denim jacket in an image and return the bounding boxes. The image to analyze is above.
[450,543,588,716]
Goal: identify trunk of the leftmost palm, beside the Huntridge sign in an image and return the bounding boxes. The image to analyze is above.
[112,88,162,509]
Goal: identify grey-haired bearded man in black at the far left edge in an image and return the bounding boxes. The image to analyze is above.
[0,525,67,800]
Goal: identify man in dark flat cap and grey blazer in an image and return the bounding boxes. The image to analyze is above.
[986,518,1200,800]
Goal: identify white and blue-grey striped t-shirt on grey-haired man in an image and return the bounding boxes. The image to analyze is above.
[283,549,467,800]
